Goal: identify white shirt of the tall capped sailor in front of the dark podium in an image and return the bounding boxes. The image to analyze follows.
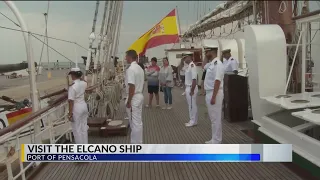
[204,58,225,91]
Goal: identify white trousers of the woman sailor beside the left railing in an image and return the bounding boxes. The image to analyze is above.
[71,102,89,144]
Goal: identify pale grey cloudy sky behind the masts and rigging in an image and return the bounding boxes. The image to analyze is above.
[0,1,222,63]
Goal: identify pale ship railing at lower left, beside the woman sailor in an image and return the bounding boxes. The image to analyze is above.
[0,93,72,180]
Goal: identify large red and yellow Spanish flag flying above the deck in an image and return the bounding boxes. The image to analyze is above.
[128,9,179,56]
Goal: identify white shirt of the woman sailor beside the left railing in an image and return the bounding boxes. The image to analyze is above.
[68,79,87,103]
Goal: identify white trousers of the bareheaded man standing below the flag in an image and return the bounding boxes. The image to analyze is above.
[126,93,144,144]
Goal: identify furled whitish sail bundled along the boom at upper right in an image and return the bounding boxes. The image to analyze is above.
[183,1,261,40]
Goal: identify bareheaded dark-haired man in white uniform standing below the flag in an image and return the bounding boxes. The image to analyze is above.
[125,50,144,144]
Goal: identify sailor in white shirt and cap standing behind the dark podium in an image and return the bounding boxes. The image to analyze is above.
[222,49,239,74]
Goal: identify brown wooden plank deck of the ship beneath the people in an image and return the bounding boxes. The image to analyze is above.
[33,88,301,180]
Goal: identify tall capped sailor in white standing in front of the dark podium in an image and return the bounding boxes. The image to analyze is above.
[204,46,225,144]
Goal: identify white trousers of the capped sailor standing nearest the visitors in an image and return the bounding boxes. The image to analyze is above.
[185,86,198,124]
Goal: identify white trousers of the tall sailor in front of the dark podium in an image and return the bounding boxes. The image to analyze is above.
[206,90,223,144]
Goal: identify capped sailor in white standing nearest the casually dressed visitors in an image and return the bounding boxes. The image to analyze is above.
[182,52,198,127]
